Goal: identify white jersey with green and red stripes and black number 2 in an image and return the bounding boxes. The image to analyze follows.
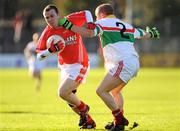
[96,15,145,63]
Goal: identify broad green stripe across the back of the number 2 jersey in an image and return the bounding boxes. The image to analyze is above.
[100,31,135,47]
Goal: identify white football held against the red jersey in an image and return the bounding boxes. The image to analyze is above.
[46,35,65,48]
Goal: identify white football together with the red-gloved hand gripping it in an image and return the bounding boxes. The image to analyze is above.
[46,35,65,53]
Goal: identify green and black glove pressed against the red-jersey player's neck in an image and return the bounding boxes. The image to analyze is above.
[58,18,73,30]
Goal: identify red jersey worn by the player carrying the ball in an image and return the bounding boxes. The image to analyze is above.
[36,11,88,65]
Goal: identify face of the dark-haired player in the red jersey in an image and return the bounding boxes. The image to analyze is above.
[43,9,59,28]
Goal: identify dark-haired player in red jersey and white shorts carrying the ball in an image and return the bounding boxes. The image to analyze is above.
[36,5,96,129]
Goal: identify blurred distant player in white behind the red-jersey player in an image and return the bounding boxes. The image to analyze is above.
[24,33,43,91]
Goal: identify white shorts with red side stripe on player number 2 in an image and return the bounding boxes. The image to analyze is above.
[106,56,140,83]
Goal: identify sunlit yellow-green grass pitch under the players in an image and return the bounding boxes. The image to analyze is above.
[0,68,180,131]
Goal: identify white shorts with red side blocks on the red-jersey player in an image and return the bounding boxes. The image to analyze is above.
[59,63,90,83]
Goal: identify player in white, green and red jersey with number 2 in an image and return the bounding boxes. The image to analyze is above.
[59,4,159,131]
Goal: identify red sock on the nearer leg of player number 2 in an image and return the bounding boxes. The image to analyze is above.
[112,109,123,125]
